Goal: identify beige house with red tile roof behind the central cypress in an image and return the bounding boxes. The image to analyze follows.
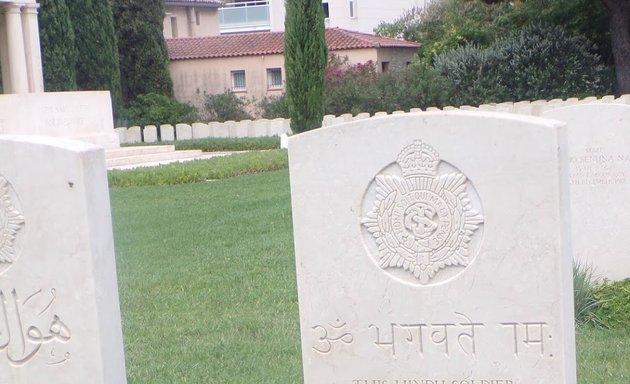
[166,28,420,105]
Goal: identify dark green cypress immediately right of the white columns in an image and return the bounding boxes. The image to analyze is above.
[38,0,77,91]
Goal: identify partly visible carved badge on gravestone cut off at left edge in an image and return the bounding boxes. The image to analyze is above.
[0,175,25,273]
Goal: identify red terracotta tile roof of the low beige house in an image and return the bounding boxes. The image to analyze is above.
[166,28,420,60]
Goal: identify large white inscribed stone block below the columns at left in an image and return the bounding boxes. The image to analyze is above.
[0,91,120,149]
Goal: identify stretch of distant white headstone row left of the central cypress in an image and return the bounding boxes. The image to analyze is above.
[115,118,291,144]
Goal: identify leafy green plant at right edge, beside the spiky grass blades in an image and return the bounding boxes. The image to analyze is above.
[593,279,630,329]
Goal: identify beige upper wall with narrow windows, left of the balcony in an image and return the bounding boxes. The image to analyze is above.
[163,6,219,39]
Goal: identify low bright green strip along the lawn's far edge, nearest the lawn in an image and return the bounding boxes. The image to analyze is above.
[108,149,289,187]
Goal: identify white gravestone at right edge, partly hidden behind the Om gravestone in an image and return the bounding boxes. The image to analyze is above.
[543,103,630,280]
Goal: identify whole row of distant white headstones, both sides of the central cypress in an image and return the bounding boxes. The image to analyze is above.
[115,94,630,144]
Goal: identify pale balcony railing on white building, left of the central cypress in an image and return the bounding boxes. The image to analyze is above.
[219,1,271,33]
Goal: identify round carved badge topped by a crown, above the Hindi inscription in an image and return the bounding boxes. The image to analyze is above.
[361,140,483,285]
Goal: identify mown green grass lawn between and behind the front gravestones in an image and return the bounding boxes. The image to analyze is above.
[111,170,630,384]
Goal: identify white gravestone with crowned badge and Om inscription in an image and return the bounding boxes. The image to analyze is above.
[289,112,576,384]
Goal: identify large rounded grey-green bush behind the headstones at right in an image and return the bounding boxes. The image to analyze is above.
[435,26,609,105]
